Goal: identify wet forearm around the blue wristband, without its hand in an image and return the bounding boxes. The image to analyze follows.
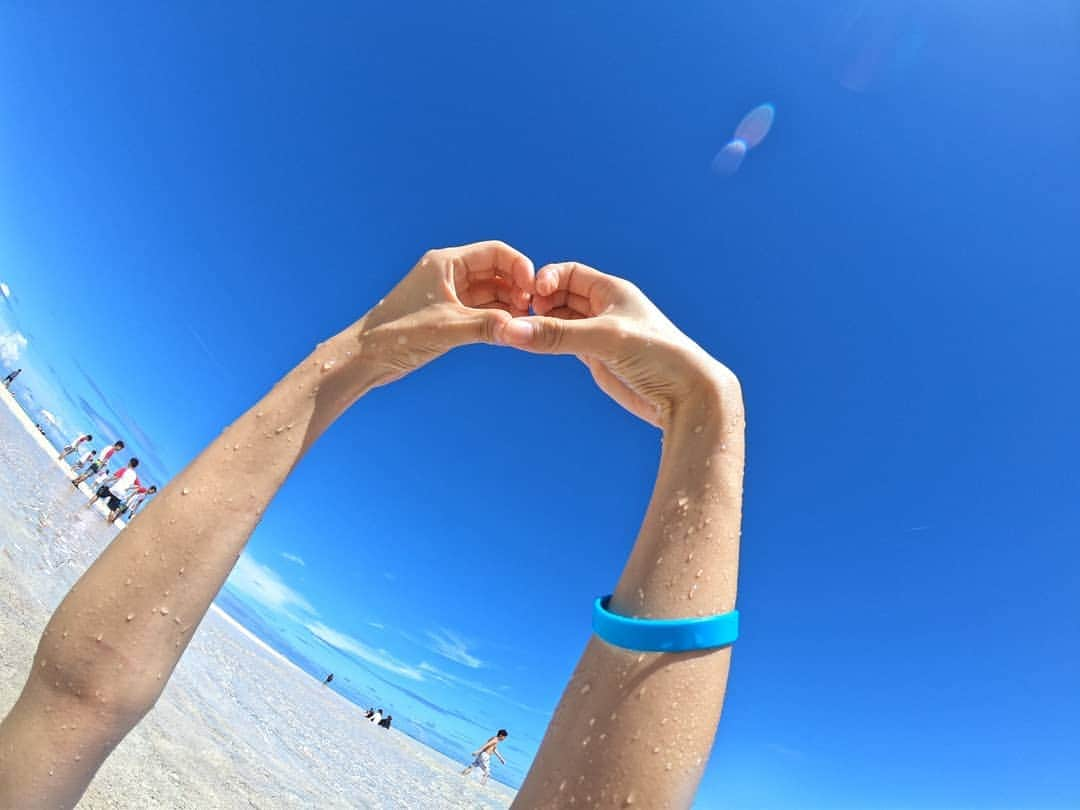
[517,378,744,808]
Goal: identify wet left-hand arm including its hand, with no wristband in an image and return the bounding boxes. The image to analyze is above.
[0,243,532,810]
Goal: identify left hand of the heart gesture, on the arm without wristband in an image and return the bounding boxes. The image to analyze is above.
[355,242,534,384]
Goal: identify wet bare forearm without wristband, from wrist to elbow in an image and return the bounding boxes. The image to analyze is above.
[35,324,375,711]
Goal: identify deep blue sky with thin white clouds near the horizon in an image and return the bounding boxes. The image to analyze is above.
[0,0,1080,808]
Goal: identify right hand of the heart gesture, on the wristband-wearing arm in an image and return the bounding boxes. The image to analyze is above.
[496,261,738,429]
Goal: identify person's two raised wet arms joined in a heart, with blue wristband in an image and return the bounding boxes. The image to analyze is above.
[0,242,746,810]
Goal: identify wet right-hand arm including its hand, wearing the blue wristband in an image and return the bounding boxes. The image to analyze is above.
[507,264,744,810]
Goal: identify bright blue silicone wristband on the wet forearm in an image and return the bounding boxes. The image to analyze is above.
[593,596,739,652]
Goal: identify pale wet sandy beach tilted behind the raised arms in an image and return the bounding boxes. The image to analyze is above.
[0,391,514,810]
